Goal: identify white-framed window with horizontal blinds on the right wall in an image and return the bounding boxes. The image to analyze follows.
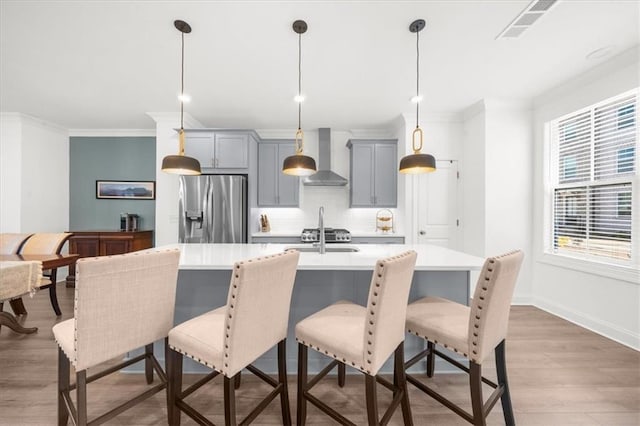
[549,90,638,264]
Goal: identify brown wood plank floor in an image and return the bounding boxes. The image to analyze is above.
[0,284,640,426]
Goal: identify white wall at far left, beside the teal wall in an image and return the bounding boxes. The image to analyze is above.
[0,114,69,232]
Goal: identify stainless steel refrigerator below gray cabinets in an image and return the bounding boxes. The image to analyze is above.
[178,175,247,243]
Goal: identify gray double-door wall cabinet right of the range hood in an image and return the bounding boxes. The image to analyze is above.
[347,139,398,207]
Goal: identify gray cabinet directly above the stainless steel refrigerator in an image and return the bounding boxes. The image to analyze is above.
[184,129,254,172]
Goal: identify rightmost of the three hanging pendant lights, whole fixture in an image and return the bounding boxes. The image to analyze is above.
[400,19,436,174]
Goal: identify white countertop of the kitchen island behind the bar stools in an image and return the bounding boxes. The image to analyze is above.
[161,244,484,271]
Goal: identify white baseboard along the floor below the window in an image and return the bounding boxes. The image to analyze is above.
[533,297,640,351]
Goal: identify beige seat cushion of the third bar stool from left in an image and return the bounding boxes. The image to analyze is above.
[296,300,367,371]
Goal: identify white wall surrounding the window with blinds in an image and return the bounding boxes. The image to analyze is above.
[533,48,640,349]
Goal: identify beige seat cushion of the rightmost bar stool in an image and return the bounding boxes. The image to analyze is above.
[407,297,470,357]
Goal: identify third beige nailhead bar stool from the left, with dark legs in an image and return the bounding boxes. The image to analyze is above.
[296,251,417,426]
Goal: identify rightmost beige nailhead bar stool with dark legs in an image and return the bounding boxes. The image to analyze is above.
[405,250,524,425]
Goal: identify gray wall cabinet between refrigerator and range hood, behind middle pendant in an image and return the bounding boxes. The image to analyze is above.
[258,140,300,207]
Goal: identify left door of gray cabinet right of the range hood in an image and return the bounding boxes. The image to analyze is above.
[350,144,375,207]
